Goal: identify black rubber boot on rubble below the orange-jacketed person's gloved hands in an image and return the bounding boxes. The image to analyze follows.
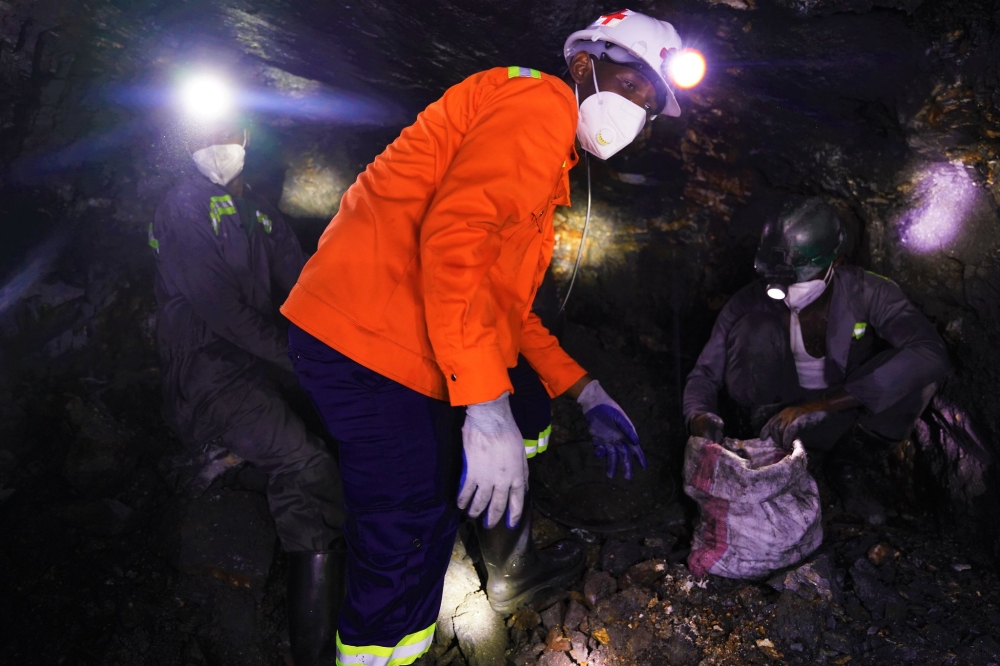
[475,507,584,615]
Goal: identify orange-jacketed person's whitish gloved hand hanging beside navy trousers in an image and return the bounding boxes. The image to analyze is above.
[458,392,528,528]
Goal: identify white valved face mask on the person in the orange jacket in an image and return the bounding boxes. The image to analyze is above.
[576,67,646,160]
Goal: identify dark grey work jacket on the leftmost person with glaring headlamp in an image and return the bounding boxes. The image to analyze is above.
[149,177,305,440]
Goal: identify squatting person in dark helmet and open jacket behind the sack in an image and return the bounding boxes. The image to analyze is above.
[684,198,950,524]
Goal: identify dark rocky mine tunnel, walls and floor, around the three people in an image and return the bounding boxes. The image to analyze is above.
[0,0,1000,666]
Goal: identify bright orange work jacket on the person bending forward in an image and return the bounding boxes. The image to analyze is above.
[281,67,585,405]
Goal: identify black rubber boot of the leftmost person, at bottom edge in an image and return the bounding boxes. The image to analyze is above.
[287,550,347,666]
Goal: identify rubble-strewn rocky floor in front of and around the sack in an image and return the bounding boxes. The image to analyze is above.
[423,488,1000,666]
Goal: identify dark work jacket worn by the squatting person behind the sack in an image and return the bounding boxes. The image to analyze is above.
[684,266,951,421]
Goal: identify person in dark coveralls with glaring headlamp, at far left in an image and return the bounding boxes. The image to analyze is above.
[149,116,346,666]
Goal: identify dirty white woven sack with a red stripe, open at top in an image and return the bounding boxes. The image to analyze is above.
[684,437,823,578]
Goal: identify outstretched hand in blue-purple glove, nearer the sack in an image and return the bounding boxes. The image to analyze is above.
[576,380,646,481]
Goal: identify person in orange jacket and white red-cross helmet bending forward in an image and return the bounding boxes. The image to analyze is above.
[282,10,681,665]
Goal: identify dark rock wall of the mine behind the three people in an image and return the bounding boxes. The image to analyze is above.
[0,0,1000,553]
